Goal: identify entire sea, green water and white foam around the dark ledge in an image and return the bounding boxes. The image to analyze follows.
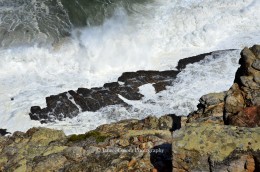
[0,0,260,134]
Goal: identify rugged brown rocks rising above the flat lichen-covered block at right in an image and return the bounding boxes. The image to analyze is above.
[187,45,260,127]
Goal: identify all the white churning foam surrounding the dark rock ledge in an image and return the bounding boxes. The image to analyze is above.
[0,0,260,134]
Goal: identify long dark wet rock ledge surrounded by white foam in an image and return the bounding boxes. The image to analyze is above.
[29,50,235,123]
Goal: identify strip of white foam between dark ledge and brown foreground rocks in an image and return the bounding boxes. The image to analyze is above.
[39,50,240,134]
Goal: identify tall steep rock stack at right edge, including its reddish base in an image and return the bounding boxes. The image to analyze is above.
[224,45,260,127]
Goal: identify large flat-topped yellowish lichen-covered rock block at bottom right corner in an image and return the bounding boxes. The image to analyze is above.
[172,123,260,171]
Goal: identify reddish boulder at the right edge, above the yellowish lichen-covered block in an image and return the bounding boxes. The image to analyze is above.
[230,106,260,127]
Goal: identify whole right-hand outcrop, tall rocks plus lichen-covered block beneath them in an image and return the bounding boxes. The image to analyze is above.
[172,45,260,172]
